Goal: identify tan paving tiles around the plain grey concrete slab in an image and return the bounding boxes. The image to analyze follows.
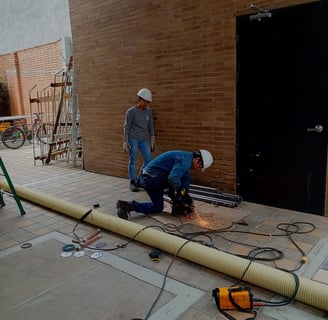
[0,146,328,320]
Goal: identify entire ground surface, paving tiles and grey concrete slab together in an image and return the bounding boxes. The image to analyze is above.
[0,145,328,320]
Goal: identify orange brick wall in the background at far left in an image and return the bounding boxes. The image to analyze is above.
[0,40,65,115]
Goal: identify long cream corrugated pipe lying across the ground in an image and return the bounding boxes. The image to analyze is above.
[0,181,328,311]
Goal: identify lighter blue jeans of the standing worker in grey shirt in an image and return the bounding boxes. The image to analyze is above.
[128,138,151,181]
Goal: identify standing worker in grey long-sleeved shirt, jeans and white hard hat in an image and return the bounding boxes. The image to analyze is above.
[123,88,155,192]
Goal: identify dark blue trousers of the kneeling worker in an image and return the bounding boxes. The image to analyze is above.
[132,176,168,214]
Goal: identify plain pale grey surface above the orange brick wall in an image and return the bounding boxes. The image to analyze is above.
[0,0,72,54]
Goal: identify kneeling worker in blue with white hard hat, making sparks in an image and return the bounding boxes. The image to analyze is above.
[116,150,213,220]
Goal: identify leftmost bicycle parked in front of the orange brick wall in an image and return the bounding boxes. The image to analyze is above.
[1,113,41,149]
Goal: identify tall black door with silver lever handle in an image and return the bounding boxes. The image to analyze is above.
[237,1,328,214]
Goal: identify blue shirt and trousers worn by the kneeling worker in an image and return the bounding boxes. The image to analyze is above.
[132,150,193,214]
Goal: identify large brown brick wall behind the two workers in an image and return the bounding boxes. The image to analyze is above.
[69,0,309,192]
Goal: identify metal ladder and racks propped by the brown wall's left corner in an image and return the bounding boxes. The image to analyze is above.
[30,56,82,167]
